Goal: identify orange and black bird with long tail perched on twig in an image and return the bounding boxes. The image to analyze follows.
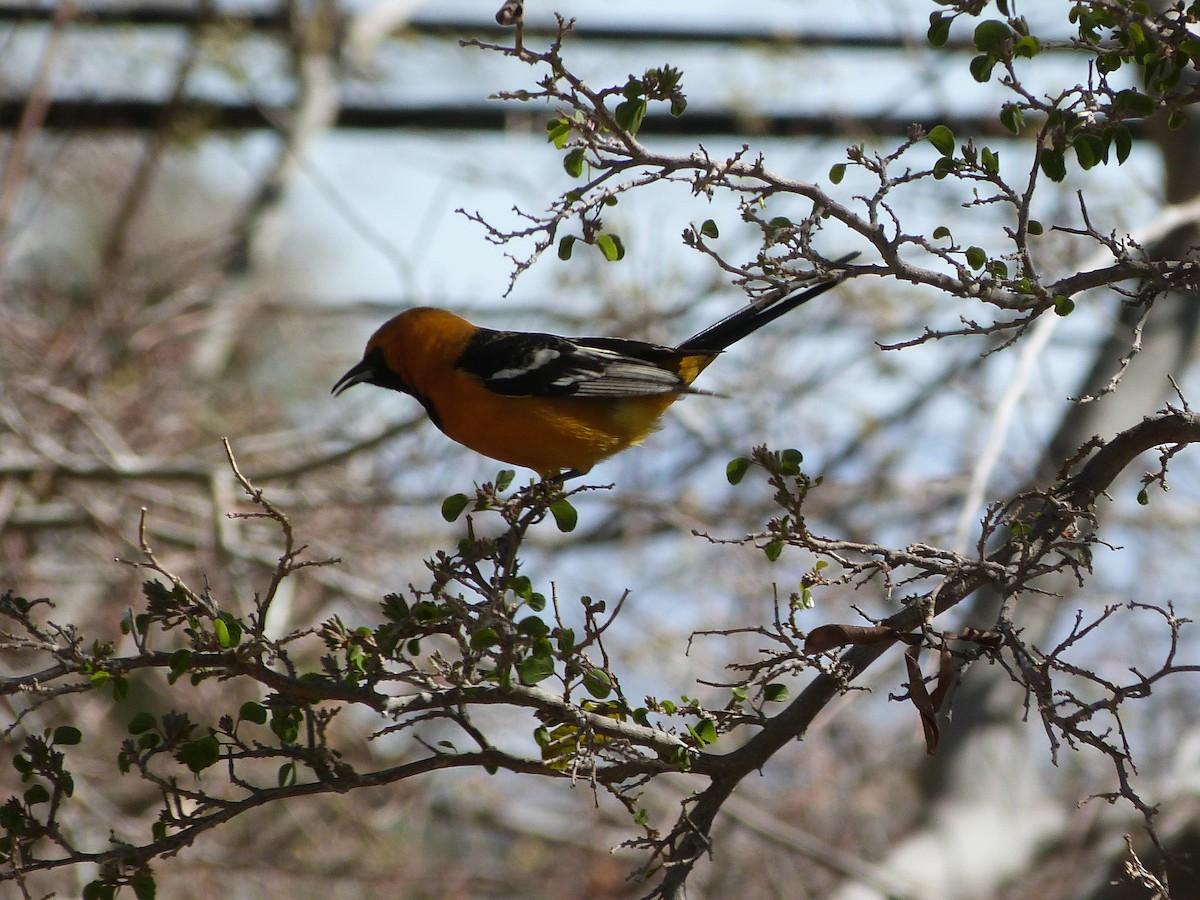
[330,264,852,481]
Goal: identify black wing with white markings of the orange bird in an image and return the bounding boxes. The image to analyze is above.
[455,329,698,397]
